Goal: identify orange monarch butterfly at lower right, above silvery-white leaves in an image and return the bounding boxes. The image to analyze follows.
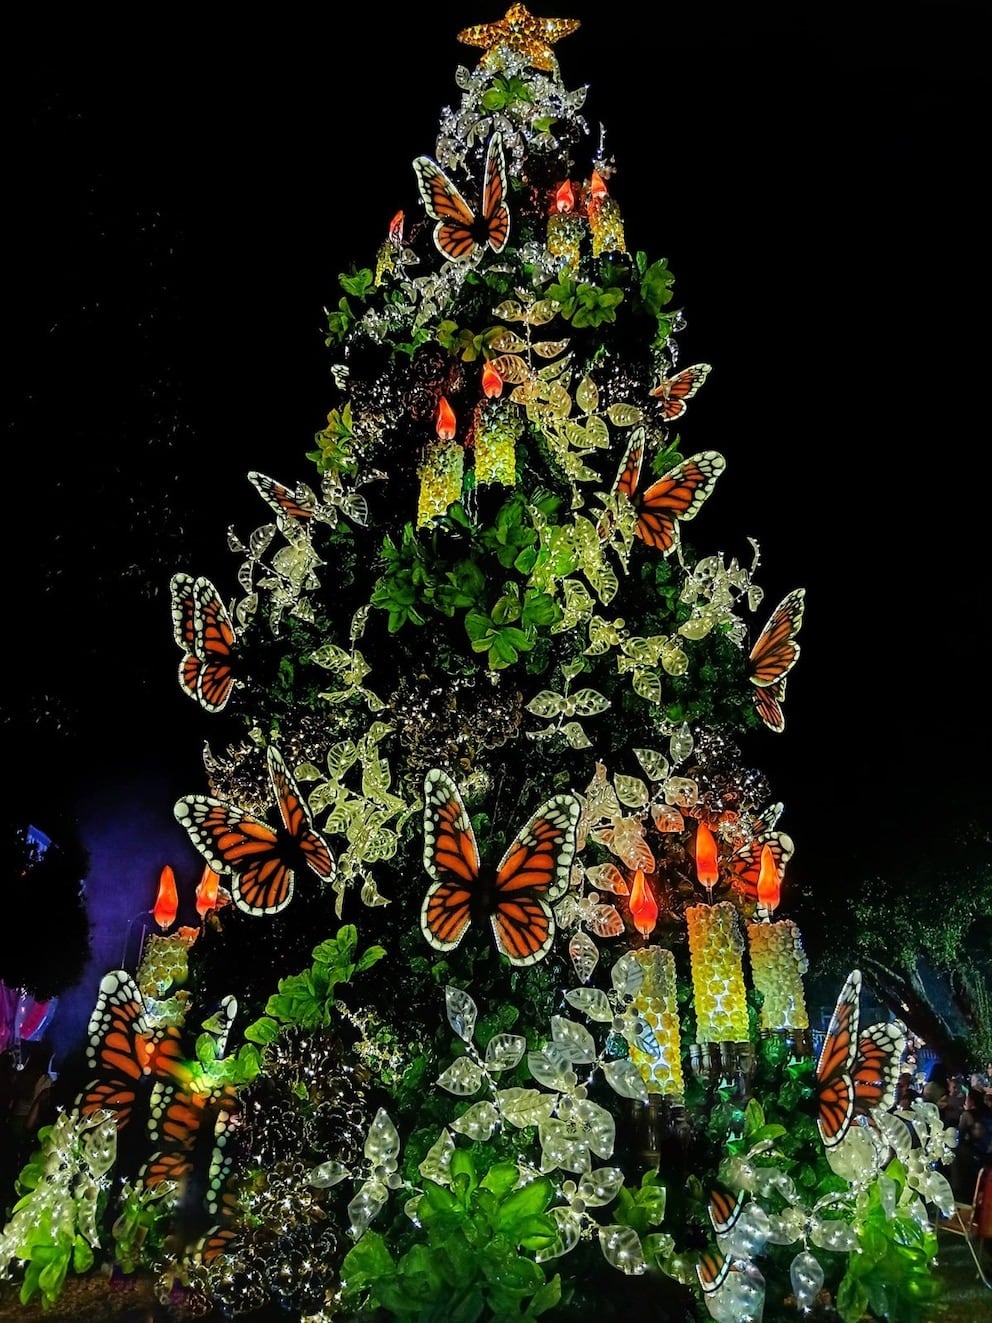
[816,970,906,1150]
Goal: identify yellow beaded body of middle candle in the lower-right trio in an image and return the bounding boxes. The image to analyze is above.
[685,901,747,1043]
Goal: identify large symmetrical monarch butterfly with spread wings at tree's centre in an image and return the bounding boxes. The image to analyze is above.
[421,767,581,966]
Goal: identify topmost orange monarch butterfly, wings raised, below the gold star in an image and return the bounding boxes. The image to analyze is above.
[414,134,509,262]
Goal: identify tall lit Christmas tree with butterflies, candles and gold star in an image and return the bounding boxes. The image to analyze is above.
[0,5,950,1323]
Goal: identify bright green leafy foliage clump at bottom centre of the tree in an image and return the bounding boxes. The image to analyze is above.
[341,1148,561,1323]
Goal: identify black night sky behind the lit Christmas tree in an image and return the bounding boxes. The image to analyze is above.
[1,0,989,1047]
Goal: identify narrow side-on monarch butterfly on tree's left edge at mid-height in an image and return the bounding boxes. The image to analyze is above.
[169,574,237,712]
